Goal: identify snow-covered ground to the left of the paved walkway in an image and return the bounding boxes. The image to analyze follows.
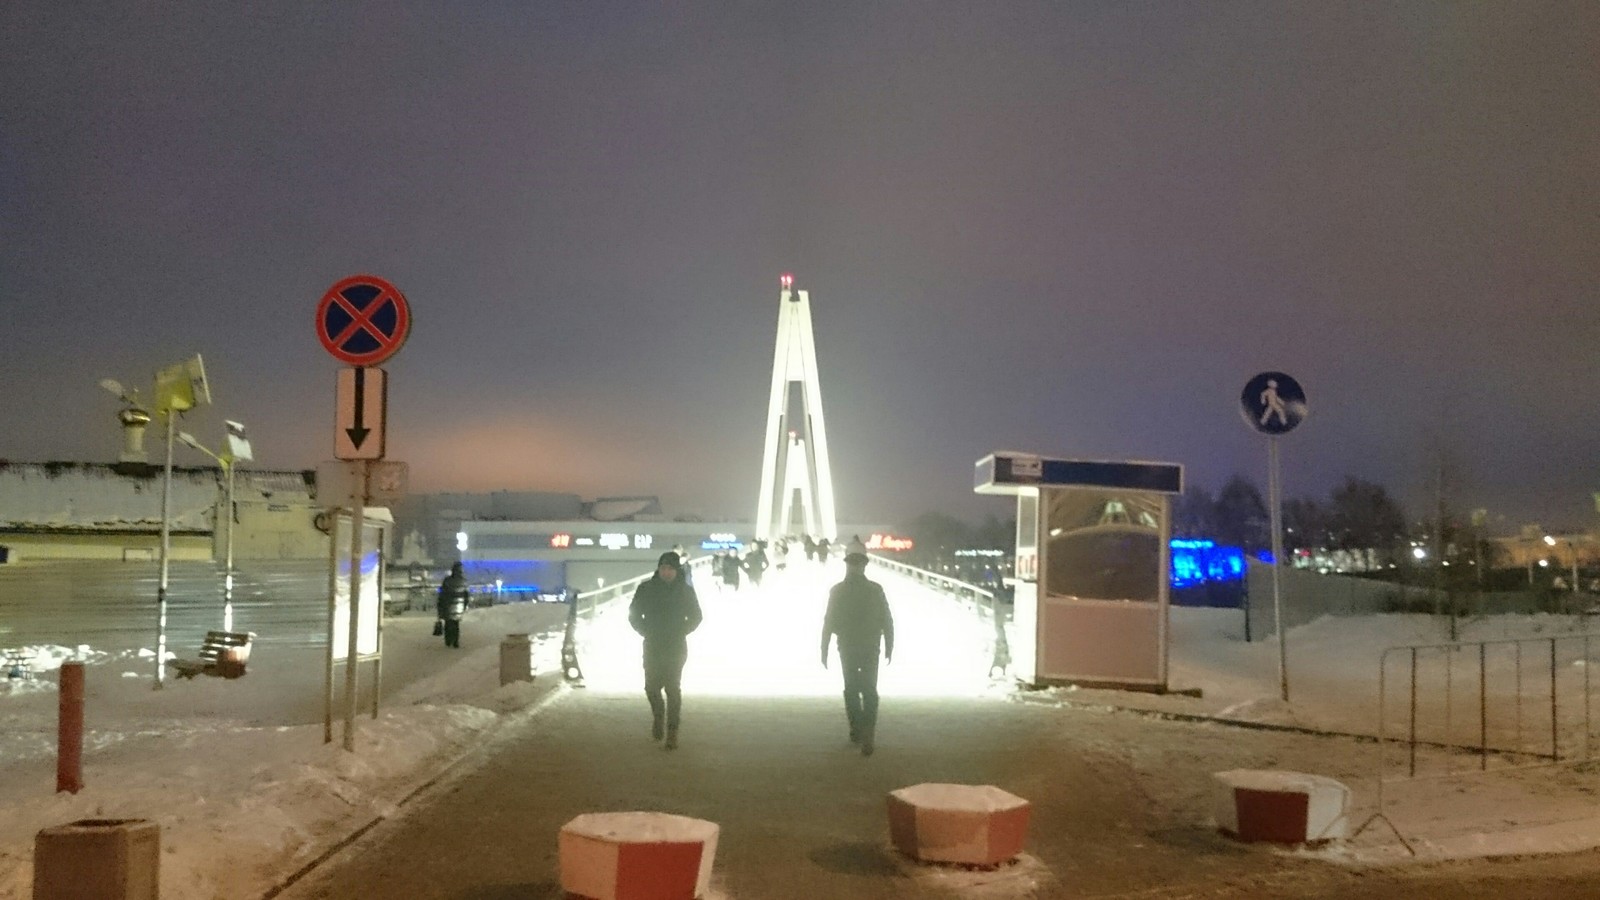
[0,604,565,900]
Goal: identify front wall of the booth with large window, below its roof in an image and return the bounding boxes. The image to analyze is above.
[1037,488,1168,690]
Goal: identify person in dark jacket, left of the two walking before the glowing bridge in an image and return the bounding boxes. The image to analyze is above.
[627,552,701,749]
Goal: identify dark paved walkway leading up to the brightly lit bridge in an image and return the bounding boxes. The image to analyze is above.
[272,682,1363,900]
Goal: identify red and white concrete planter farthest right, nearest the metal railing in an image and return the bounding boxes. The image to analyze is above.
[1211,769,1350,844]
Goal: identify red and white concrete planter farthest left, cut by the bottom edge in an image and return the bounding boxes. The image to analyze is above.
[560,812,720,900]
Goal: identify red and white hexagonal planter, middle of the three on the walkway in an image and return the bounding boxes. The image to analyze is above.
[888,783,1034,866]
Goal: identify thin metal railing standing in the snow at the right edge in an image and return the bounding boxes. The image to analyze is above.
[1352,633,1600,850]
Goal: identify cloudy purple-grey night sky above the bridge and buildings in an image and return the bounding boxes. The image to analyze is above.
[0,0,1600,530]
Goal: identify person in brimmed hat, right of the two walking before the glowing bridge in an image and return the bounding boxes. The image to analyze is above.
[822,552,894,756]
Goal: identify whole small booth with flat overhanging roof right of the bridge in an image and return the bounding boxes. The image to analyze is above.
[974,452,1184,692]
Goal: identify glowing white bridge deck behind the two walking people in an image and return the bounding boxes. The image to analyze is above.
[578,560,1008,705]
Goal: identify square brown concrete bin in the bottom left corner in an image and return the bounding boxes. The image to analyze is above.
[34,818,162,900]
